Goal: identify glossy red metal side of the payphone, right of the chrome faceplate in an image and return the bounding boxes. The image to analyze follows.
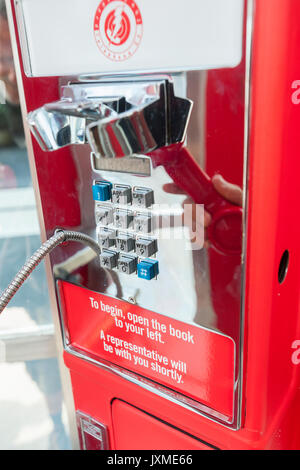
[240,0,300,442]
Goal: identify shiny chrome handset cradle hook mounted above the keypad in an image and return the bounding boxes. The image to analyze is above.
[28,78,192,158]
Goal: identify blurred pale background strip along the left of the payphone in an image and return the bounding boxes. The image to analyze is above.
[0,0,70,450]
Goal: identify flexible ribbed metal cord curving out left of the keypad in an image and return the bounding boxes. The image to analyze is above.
[0,230,100,314]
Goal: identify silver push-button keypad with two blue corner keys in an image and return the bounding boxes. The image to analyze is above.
[92,181,158,280]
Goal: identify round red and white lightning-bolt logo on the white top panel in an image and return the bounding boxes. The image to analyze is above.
[94,0,143,62]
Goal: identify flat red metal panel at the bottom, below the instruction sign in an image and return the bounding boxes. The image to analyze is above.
[112,400,212,450]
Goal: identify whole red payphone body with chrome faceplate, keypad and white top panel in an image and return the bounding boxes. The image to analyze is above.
[8,0,300,449]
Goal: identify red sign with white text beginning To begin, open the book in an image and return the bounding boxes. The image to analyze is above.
[58,281,235,418]
